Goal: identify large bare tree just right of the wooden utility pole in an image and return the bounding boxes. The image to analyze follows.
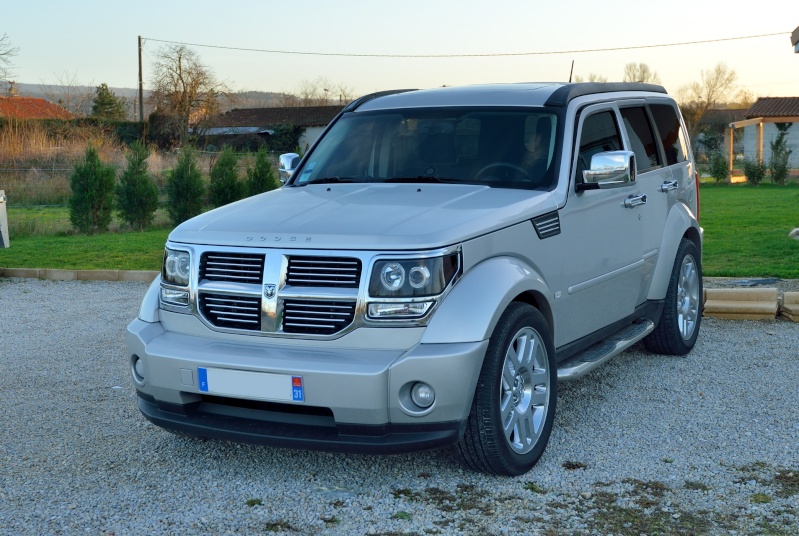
[150,45,228,144]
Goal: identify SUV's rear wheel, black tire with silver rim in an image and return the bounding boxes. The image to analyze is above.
[644,238,702,355]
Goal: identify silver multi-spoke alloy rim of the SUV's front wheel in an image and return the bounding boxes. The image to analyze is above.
[499,327,550,454]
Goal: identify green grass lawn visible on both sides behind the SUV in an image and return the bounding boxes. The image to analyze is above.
[0,183,799,279]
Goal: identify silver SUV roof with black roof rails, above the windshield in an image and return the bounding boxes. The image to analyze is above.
[344,82,666,112]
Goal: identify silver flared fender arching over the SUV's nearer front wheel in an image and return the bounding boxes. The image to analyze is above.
[421,257,552,344]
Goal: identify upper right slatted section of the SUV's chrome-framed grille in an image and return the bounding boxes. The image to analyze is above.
[286,257,361,288]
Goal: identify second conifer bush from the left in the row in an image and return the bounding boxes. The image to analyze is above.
[117,141,158,231]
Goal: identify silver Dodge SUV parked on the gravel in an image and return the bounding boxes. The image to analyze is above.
[128,83,702,475]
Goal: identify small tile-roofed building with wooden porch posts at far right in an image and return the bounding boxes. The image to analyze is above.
[726,97,799,169]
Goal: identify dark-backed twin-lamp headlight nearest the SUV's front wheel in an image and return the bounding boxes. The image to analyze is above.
[369,253,458,298]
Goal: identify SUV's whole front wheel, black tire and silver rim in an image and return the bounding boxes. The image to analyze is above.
[457,302,558,476]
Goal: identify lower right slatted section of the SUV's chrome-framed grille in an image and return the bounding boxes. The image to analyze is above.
[283,300,355,335]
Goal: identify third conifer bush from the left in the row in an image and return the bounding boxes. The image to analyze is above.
[166,148,205,225]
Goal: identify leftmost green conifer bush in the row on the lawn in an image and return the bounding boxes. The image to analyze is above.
[69,145,116,234]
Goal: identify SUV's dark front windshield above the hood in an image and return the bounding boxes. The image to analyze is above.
[292,108,557,188]
